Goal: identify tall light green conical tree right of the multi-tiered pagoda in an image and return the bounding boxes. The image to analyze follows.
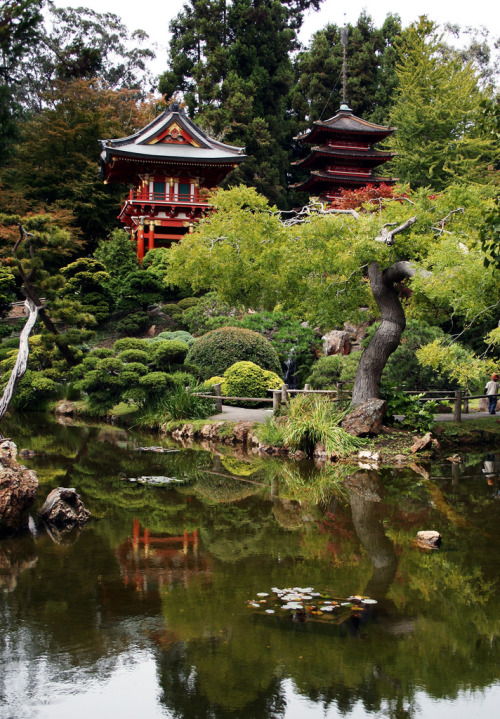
[389,17,498,190]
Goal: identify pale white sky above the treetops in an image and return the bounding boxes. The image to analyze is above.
[55,0,500,77]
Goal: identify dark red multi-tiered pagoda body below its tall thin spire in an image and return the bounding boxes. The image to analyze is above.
[292,104,397,201]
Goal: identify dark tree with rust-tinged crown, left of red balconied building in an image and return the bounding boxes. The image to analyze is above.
[1,79,159,249]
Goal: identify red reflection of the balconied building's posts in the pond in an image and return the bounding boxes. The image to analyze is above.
[116,519,211,593]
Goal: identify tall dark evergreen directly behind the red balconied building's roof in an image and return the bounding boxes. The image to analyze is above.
[159,0,321,206]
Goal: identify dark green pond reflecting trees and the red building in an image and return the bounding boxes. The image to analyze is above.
[0,416,500,719]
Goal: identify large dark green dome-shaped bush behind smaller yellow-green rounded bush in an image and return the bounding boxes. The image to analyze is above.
[188,327,281,378]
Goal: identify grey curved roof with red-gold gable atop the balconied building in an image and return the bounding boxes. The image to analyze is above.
[99,103,246,182]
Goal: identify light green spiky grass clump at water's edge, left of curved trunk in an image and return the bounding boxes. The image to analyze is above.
[260,395,365,458]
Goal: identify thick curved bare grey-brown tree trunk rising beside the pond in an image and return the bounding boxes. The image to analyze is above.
[352,262,422,405]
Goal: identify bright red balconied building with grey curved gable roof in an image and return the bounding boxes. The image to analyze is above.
[99,103,246,260]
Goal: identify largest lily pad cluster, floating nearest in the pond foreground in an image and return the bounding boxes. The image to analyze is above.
[247,587,377,622]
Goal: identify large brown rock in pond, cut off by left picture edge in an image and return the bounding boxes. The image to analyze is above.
[0,440,38,530]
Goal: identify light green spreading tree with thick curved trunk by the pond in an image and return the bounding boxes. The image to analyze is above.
[169,186,498,398]
